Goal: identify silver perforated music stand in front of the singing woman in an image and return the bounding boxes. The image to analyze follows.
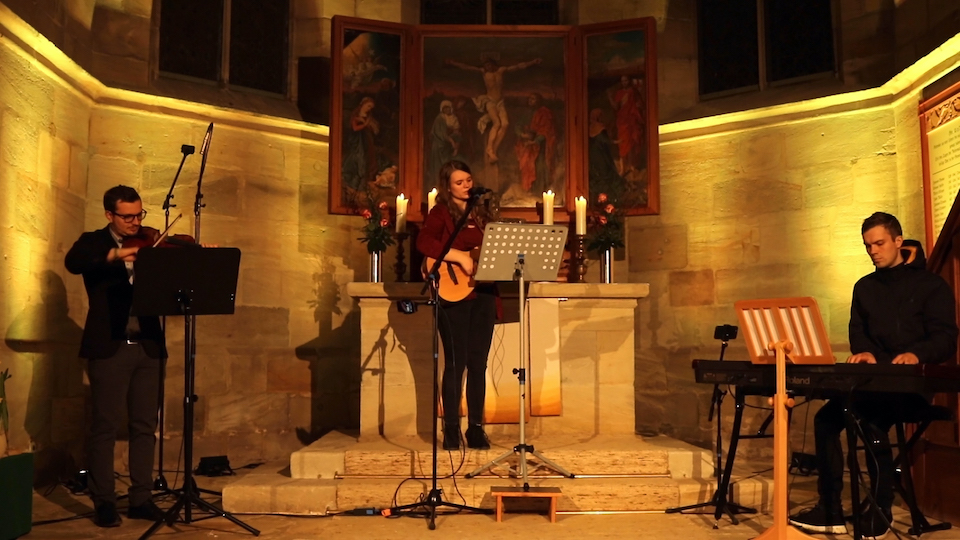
[465,223,574,491]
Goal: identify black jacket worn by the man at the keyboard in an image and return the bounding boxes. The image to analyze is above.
[850,241,957,364]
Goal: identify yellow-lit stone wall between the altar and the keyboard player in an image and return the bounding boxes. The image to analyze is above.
[618,67,960,452]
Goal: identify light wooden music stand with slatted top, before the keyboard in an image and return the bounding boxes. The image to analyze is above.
[734,297,836,540]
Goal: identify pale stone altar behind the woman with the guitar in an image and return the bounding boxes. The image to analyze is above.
[347,282,650,441]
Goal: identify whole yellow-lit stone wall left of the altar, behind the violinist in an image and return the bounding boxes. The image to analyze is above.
[0,6,367,480]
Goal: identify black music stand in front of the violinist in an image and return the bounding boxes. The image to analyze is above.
[131,248,260,539]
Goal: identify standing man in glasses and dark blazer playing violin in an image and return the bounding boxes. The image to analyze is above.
[64,185,167,527]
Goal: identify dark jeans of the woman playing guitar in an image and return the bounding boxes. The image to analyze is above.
[437,291,497,425]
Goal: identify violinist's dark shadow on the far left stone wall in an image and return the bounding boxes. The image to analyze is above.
[4,270,88,487]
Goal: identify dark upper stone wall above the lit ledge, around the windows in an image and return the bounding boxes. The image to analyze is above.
[4,0,960,122]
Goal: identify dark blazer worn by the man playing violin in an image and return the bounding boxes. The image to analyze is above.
[64,227,167,360]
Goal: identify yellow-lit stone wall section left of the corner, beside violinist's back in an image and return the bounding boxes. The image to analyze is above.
[0,8,94,480]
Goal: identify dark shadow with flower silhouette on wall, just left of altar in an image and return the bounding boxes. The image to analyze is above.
[295,257,360,445]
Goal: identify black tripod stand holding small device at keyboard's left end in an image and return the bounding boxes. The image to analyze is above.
[666,324,757,529]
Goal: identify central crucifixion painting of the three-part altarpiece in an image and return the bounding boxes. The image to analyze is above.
[422,36,568,207]
